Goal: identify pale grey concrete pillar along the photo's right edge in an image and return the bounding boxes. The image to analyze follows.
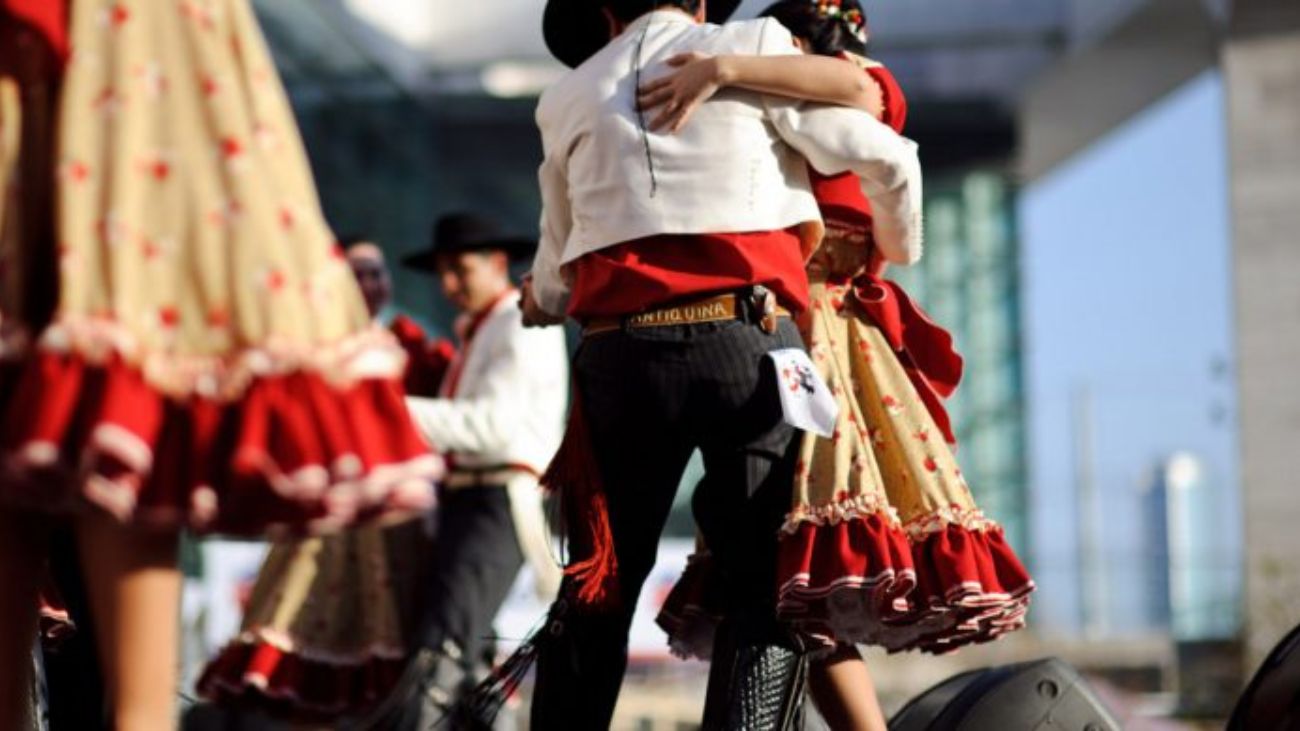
[1223,0,1300,669]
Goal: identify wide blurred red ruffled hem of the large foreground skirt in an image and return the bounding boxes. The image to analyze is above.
[0,351,442,535]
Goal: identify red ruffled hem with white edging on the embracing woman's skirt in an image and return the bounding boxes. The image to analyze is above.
[777,514,1034,653]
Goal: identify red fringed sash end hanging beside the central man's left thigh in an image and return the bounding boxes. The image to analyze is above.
[542,388,619,610]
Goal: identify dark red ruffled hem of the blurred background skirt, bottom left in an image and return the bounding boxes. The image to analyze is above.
[198,639,406,723]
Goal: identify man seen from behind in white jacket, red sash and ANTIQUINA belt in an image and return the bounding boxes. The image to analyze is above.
[523,0,920,730]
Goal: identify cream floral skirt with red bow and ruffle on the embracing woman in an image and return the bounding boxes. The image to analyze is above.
[659,242,1034,657]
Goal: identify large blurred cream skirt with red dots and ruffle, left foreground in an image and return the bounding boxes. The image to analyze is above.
[0,0,442,535]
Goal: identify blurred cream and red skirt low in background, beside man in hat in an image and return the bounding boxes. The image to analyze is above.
[198,520,429,723]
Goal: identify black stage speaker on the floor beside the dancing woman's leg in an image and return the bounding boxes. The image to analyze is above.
[889,657,1119,731]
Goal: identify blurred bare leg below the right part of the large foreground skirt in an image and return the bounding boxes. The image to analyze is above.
[78,515,181,731]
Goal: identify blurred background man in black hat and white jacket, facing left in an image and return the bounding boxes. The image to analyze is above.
[385,213,568,728]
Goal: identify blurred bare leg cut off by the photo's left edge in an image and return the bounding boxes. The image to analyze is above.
[0,511,46,728]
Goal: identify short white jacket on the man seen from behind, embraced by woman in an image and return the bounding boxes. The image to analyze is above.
[533,10,922,315]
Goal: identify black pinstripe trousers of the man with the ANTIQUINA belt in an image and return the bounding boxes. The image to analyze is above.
[532,319,802,730]
